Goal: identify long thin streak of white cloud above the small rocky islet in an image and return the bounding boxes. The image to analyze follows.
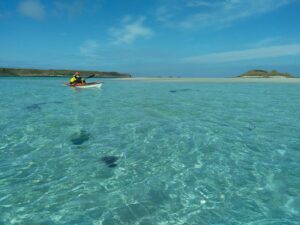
[182,44,300,64]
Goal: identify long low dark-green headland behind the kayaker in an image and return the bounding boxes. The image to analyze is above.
[0,68,132,78]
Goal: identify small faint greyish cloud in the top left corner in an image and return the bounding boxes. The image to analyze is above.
[18,0,46,20]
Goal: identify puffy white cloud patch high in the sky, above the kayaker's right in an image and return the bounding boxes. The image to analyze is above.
[109,16,153,44]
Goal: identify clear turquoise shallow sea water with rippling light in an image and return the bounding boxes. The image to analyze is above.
[0,78,300,225]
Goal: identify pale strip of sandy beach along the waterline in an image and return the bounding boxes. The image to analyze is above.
[117,77,300,83]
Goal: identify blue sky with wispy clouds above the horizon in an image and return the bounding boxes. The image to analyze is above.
[0,0,300,77]
